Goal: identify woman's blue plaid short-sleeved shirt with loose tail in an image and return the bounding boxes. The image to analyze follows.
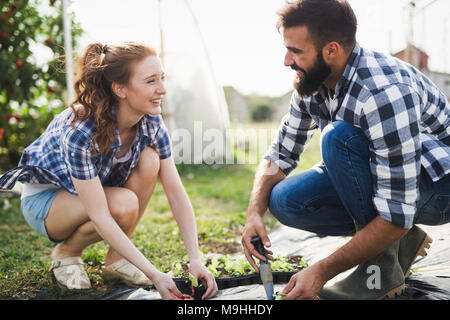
[0,107,171,195]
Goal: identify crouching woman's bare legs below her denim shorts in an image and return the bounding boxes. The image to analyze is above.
[45,147,159,265]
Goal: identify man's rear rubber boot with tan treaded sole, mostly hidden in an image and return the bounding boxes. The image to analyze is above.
[398,226,433,278]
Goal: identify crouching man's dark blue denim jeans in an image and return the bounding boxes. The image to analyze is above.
[269,121,450,236]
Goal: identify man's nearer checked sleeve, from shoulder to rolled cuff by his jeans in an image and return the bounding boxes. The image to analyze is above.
[361,84,421,229]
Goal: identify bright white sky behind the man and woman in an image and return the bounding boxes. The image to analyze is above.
[71,0,450,96]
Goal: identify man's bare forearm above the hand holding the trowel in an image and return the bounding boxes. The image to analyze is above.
[247,160,286,216]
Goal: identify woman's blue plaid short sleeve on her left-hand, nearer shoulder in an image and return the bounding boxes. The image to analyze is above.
[61,127,98,180]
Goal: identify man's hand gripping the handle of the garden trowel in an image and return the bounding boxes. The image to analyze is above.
[241,214,273,272]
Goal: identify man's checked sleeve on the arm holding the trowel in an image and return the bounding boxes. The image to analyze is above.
[264,91,318,175]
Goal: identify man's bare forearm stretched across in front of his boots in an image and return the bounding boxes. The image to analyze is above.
[317,217,408,281]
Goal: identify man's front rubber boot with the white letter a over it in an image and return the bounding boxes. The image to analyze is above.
[318,240,405,300]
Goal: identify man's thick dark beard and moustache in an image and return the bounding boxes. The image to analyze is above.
[291,51,331,98]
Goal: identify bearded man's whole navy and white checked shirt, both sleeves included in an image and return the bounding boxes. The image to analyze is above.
[265,44,450,228]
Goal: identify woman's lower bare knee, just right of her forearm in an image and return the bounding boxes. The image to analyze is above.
[109,188,139,228]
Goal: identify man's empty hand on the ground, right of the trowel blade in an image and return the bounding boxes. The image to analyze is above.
[282,264,327,300]
